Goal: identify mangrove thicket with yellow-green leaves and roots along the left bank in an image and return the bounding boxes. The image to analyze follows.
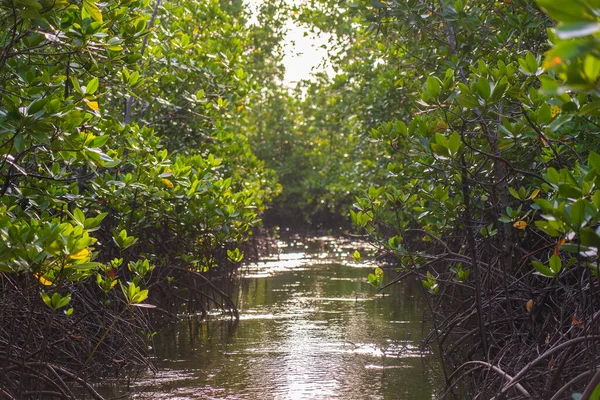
[0,0,279,398]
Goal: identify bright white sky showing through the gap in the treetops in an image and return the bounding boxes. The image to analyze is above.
[244,0,333,86]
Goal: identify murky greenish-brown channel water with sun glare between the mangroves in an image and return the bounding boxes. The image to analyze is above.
[115,237,441,400]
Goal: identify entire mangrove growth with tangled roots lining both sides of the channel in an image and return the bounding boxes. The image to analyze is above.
[0,0,600,399]
